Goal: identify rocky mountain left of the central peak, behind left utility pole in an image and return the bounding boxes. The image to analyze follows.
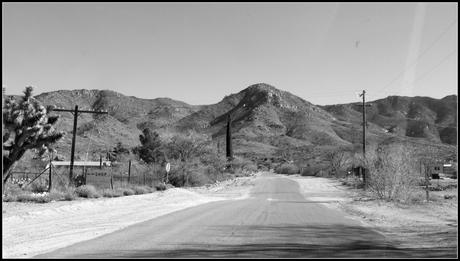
[30,90,200,158]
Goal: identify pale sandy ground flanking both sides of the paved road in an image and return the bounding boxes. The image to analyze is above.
[2,173,458,258]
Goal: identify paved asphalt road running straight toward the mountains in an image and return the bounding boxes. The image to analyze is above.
[36,175,455,258]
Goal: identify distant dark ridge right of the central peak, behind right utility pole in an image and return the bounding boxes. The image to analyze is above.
[323,95,457,145]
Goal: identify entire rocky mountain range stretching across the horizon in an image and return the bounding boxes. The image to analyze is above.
[3,83,457,172]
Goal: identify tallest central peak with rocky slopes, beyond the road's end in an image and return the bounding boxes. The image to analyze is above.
[176,84,346,153]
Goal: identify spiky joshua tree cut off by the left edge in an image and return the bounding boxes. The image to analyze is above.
[3,86,64,182]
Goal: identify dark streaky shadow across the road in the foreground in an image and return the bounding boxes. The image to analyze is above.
[66,224,457,258]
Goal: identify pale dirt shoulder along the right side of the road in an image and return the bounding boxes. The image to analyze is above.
[288,175,458,252]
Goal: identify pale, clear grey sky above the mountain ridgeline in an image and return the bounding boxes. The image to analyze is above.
[2,3,458,105]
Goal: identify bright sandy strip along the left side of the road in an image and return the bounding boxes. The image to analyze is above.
[2,176,257,258]
